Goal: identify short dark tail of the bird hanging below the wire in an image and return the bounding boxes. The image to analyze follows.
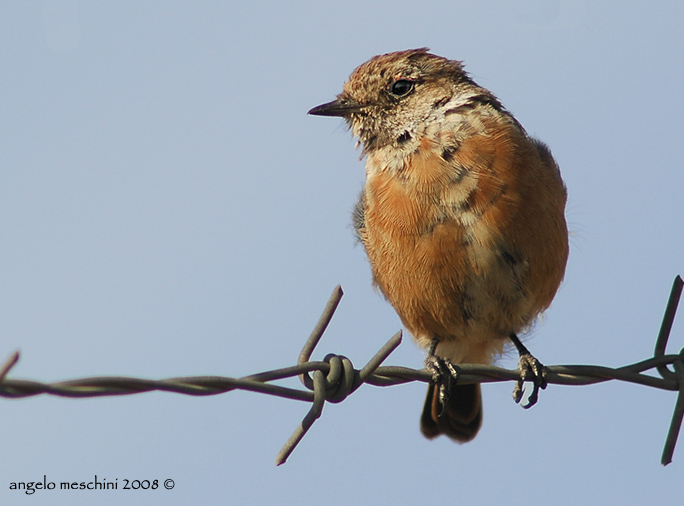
[420,381,482,443]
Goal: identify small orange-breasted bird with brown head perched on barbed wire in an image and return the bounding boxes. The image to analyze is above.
[309,48,569,443]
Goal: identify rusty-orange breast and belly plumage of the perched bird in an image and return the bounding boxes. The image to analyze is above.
[361,118,567,362]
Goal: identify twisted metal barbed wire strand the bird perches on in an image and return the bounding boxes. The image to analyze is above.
[0,276,684,465]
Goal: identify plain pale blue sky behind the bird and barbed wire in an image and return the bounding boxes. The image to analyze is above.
[0,0,684,505]
